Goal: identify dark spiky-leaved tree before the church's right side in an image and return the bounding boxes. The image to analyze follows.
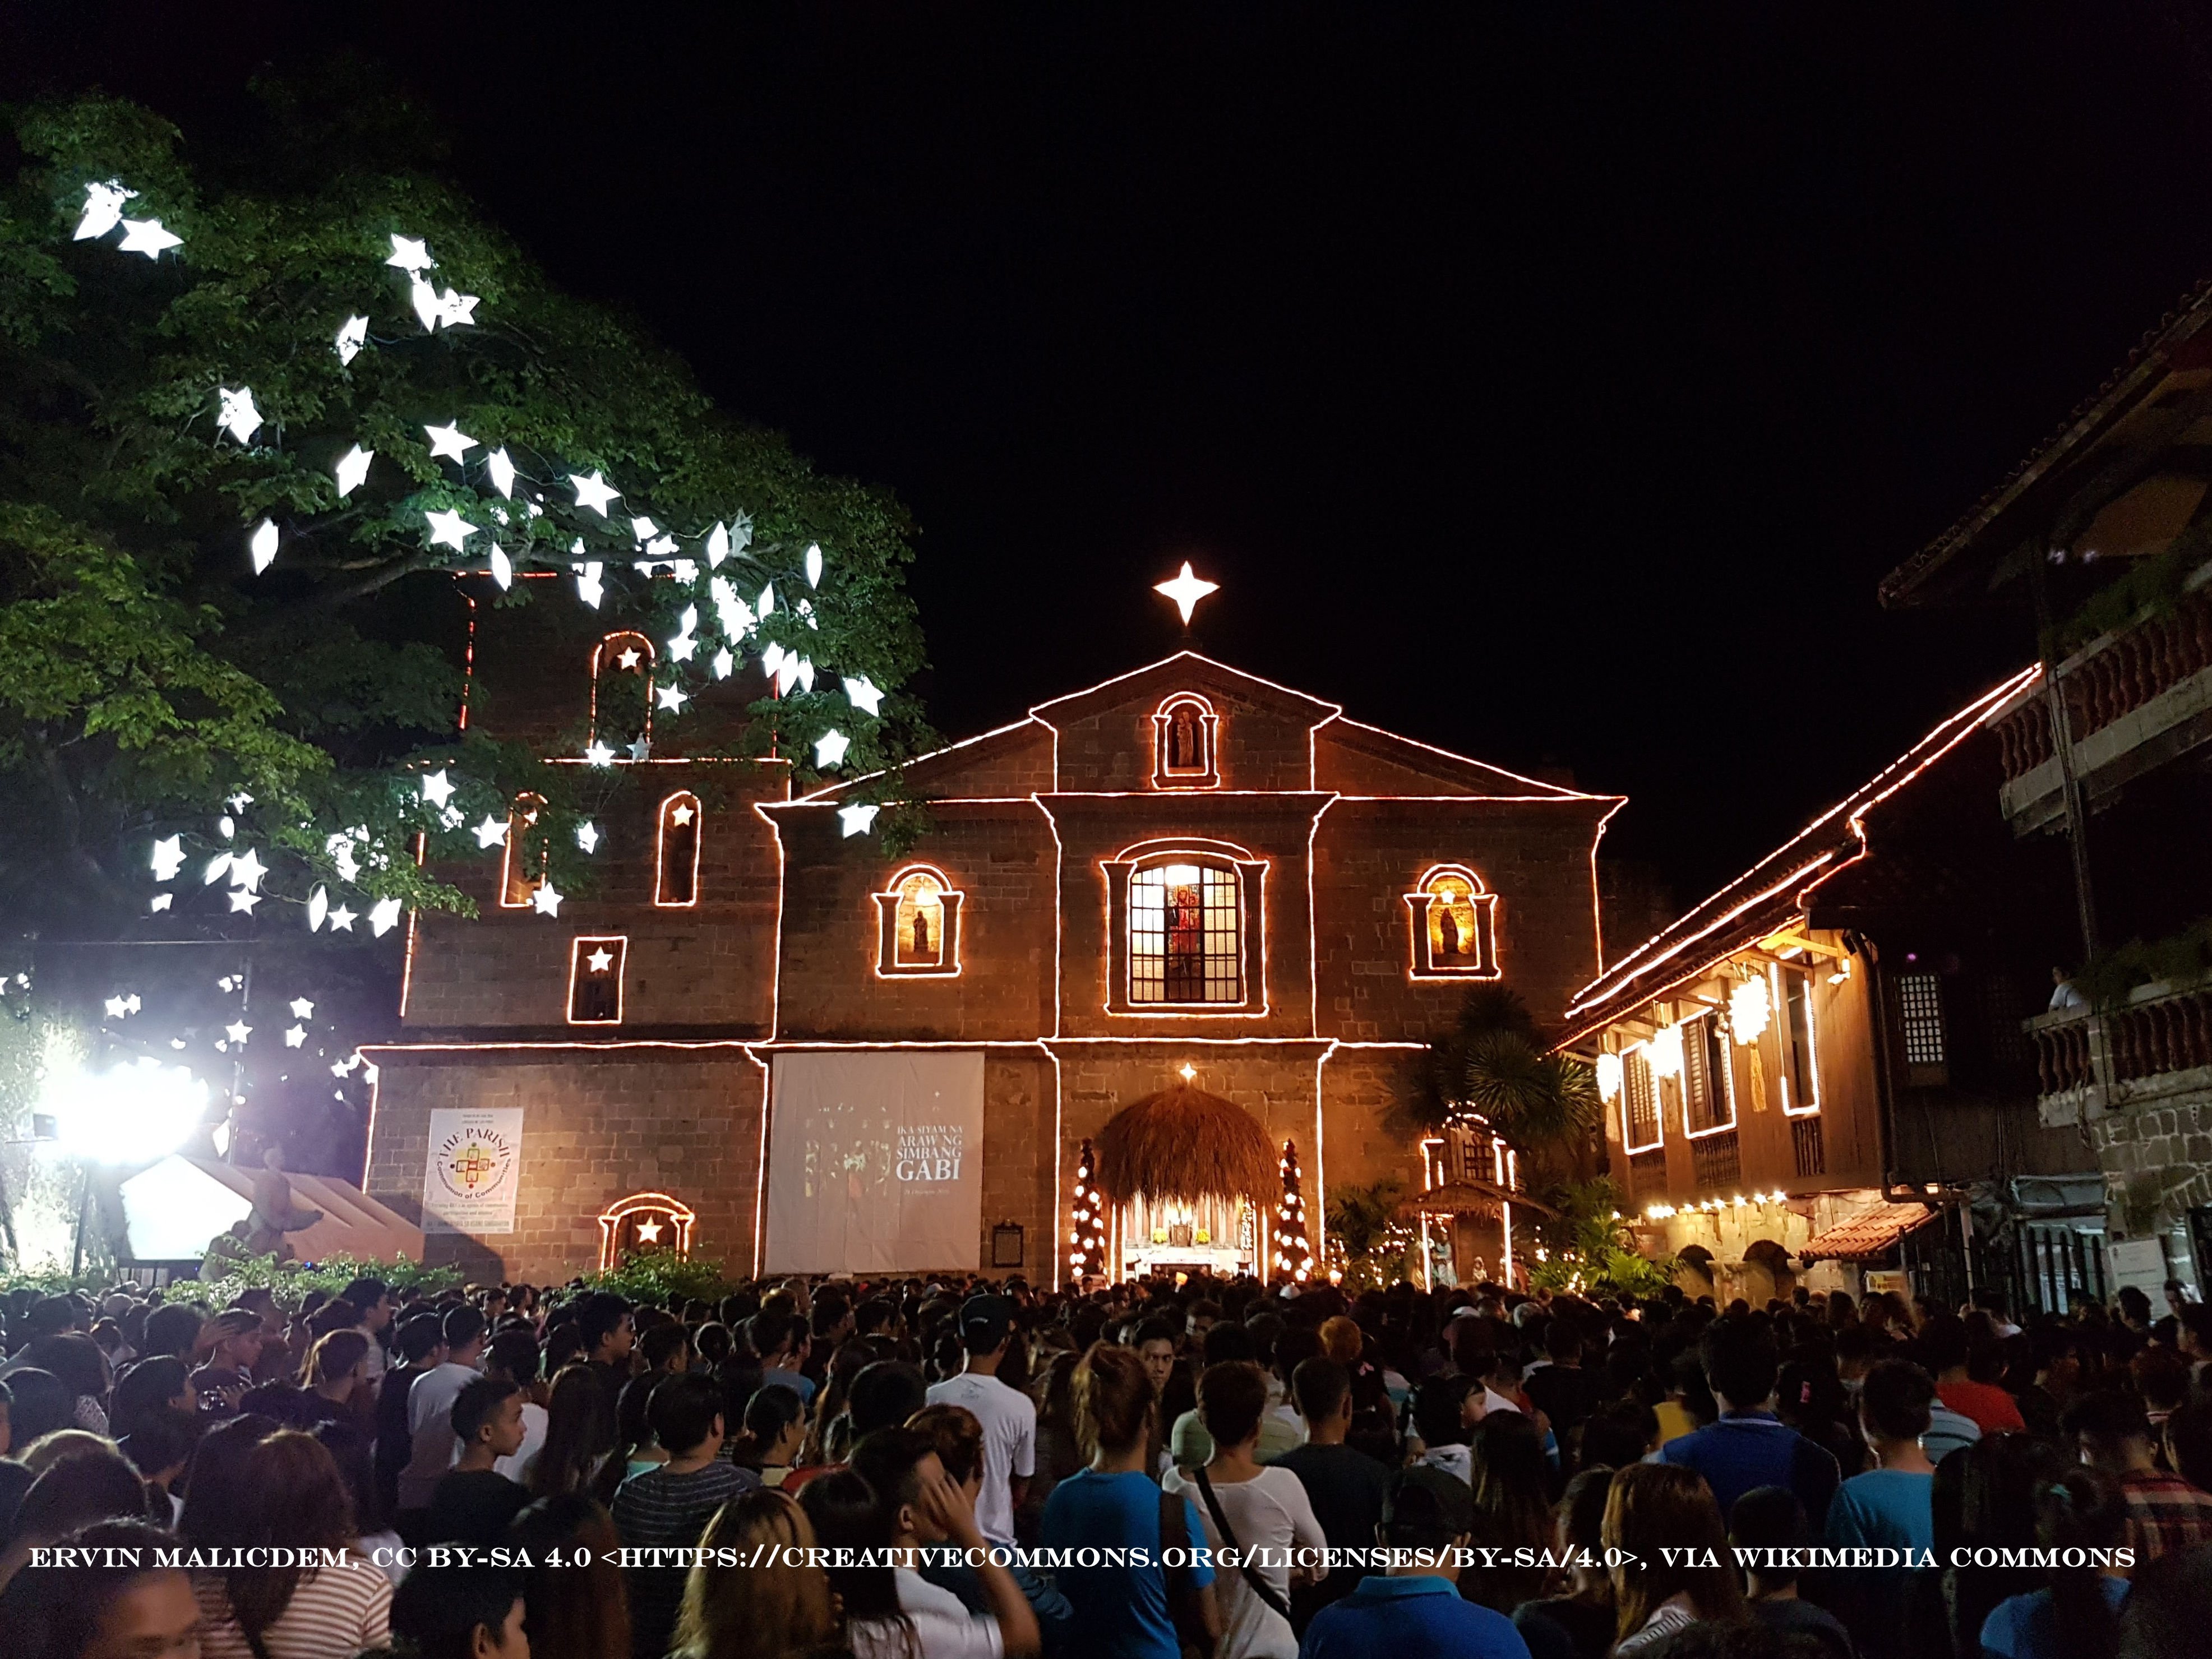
[1385,987,1601,1186]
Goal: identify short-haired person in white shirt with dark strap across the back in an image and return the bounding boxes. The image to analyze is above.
[1161,1360,1329,1659]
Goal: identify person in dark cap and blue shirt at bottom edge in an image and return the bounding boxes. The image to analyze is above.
[1299,1467,1528,1659]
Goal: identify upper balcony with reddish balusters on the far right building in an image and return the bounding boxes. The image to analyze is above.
[1991,564,2212,834]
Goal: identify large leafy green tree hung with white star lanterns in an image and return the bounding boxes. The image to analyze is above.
[0,84,927,931]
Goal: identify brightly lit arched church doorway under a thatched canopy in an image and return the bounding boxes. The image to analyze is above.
[1097,1084,1278,1278]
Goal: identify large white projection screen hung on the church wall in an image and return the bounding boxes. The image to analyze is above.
[765,1048,982,1274]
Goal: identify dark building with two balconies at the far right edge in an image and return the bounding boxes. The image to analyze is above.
[1882,285,2212,1301]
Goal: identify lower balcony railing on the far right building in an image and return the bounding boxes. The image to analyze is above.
[2026,980,2212,1124]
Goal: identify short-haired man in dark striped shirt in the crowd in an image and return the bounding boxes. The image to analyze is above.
[613,1371,761,1655]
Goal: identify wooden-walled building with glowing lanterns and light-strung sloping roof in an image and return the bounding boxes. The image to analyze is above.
[1562,670,2104,1307]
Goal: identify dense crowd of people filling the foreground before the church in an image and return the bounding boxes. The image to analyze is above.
[0,1276,2212,1659]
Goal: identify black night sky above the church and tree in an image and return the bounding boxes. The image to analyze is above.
[13,0,2212,903]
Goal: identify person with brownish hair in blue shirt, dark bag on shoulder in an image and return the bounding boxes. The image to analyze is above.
[1037,1343,1221,1659]
